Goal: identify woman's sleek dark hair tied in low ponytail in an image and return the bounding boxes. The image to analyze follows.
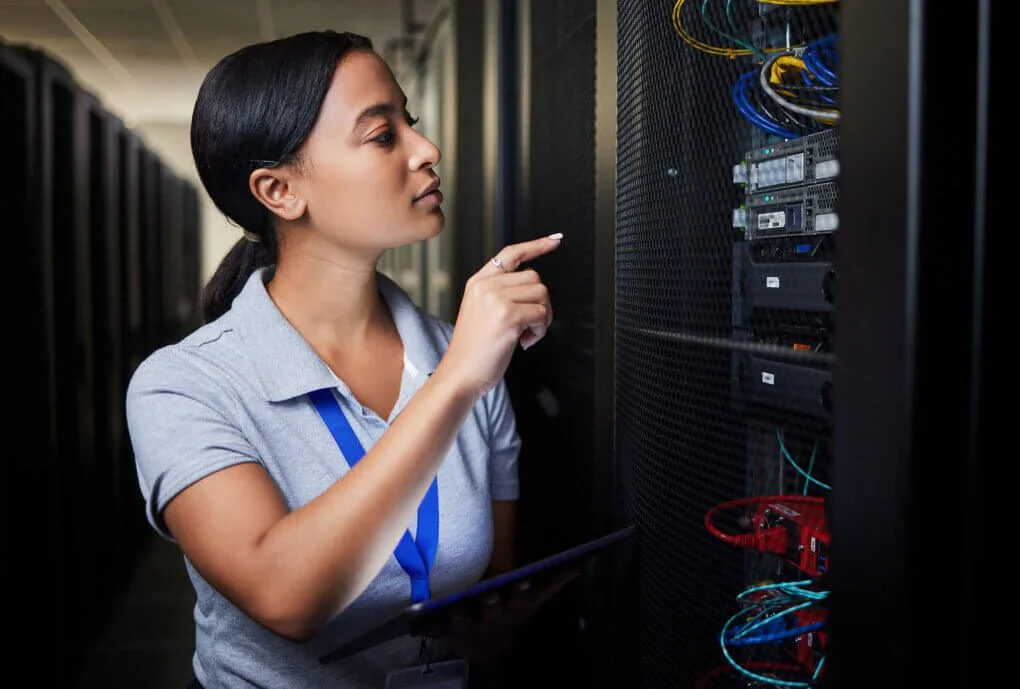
[191,31,372,322]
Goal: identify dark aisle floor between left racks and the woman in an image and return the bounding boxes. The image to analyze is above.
[70,538,195,689]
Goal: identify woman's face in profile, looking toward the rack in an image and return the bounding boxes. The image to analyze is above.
[285,51,446,252]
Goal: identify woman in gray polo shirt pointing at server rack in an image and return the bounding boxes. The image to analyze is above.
[126,32,559,689]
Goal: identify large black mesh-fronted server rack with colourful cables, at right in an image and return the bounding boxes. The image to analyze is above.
[603,0,987,689]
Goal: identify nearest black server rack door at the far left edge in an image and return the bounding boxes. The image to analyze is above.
[0,39,62,657]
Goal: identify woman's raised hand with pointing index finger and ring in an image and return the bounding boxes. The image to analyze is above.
[442,235,560,395]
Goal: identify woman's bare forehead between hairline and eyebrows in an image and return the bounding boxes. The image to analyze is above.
[320,50,404,124]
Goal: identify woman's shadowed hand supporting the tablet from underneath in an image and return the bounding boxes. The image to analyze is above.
[445,567,580,663]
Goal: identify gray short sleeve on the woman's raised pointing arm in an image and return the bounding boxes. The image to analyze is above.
[124,348,257,541]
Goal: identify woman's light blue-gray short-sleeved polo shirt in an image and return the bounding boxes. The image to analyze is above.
[126,268,520,689]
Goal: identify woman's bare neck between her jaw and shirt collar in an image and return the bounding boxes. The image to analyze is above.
[266,247,391,357]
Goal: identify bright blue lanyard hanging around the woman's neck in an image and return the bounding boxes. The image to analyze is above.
[308,389,440,603]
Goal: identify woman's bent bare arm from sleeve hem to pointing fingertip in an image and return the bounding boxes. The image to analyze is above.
[151,239,559,640]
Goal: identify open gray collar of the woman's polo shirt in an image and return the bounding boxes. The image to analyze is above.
[230,266,440,402]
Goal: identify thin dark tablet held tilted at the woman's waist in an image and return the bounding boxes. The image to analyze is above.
[319,525,638,665]
